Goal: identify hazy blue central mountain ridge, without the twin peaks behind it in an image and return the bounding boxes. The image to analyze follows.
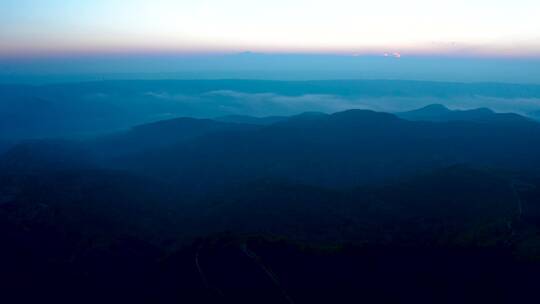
[116,110,540,188]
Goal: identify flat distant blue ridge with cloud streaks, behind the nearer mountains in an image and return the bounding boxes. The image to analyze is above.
[4,80,540,140]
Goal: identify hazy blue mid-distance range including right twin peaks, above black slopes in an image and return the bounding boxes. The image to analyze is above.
[4,106,540,187]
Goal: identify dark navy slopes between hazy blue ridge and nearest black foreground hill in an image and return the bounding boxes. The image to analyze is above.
[0,167,540,254]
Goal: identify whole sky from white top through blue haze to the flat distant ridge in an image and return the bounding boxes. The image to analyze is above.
[0,0,540,84]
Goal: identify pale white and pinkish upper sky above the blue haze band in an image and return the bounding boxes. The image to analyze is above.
[0,0,540,57]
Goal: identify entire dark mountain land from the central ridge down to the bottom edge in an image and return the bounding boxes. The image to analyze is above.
[0,106,540,303]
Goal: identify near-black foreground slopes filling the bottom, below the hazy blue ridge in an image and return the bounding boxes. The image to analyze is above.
[0,166,540,303]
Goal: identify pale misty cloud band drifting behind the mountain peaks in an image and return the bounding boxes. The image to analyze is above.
[140,90,540,117]
